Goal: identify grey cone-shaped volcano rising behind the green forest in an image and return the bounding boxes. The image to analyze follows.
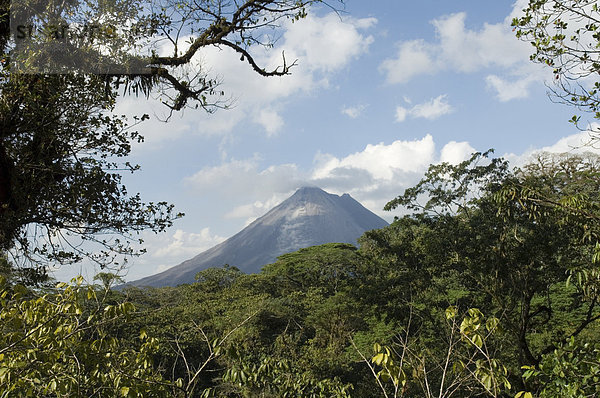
[130,187,388,287]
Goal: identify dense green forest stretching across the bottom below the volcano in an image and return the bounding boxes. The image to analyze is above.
[0,154,600,397]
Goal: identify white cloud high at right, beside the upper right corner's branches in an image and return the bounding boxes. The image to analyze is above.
[380,8,547,101]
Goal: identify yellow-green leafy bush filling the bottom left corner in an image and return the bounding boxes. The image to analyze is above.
[0,277,170,397]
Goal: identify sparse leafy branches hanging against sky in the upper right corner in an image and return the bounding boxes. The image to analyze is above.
[512,0,600,142]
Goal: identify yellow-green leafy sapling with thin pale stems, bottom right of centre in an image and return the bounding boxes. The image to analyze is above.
[370,307,511,397]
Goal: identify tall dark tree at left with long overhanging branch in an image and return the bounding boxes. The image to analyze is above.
[0,0,332,279]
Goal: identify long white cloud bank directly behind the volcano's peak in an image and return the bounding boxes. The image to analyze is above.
[186,135,482,225]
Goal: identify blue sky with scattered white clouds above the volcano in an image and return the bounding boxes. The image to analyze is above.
[55,0,600,280]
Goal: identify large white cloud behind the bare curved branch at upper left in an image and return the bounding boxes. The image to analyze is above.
[117,13,377,148]
